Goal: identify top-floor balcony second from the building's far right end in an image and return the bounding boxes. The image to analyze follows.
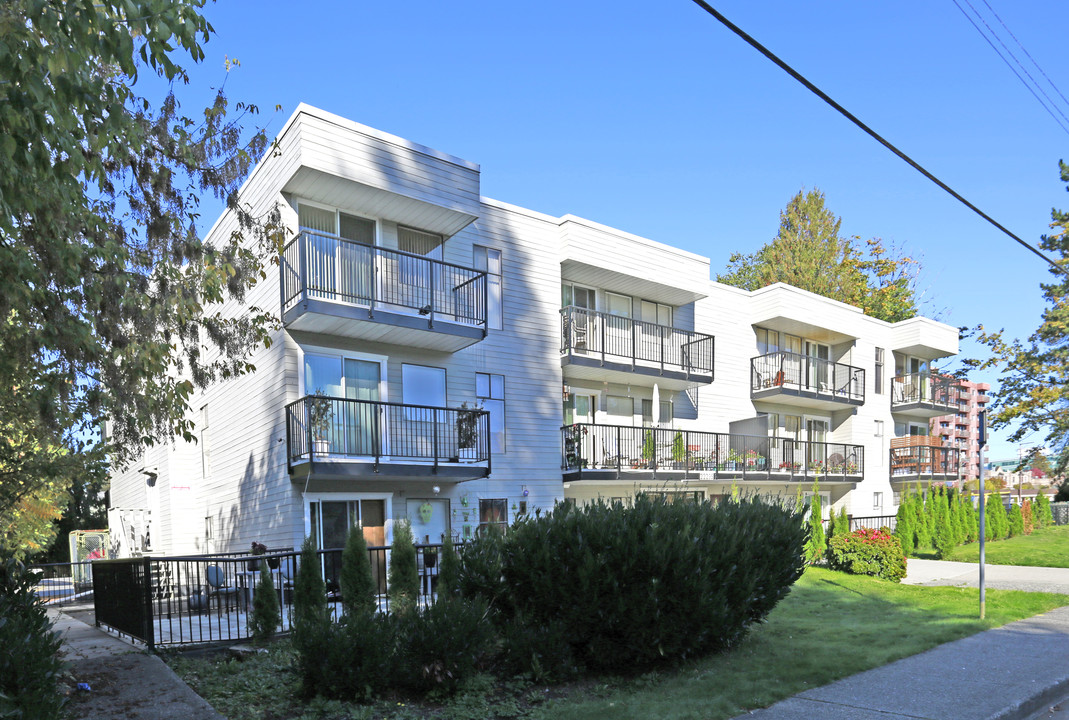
[749,350,865,410]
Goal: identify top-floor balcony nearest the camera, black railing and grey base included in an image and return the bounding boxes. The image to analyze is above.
[281,231,486,351]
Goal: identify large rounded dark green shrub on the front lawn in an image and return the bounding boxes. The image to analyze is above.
[461,494,808,672]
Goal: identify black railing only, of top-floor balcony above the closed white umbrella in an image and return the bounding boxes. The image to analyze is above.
[560,306,714,375]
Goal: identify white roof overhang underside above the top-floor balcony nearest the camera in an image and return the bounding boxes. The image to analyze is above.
[282,168,478,237]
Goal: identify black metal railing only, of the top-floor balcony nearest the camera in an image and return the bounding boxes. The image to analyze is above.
[282,231,486,327]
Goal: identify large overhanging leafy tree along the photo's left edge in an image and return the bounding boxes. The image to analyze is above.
[0,0,282,544]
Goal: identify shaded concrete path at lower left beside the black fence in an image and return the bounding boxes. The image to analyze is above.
[48,609,223,720]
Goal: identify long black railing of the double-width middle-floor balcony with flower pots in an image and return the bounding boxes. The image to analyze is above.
[561,423,865,481]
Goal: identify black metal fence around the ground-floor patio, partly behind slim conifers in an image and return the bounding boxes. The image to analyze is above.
[93,545,441,647]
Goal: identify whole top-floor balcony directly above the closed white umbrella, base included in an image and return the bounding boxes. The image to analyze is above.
[560,306,714,390]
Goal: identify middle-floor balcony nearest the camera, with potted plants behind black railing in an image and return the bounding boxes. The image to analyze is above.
[285,395,491,480]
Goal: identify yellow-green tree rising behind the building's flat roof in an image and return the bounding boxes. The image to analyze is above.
[716,189,918,323]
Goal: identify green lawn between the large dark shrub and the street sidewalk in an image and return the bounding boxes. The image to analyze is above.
[169,568,1069,720]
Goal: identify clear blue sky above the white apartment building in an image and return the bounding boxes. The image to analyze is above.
[158,0,1069,458]
